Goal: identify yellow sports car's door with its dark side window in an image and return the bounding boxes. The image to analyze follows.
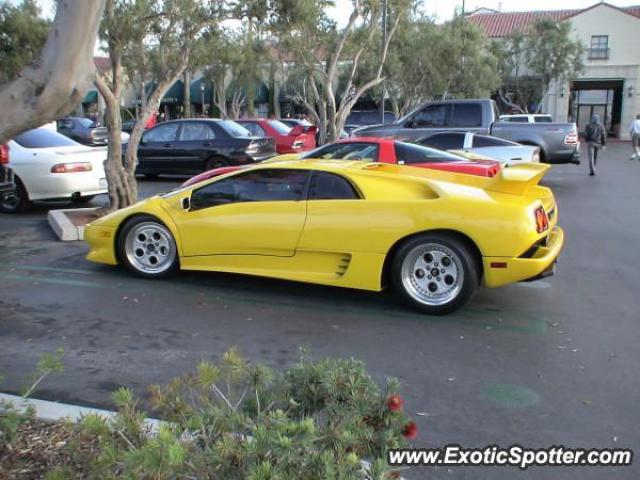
[175,168,310,257]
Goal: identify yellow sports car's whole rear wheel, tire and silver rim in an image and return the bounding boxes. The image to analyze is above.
[391,234,480,315]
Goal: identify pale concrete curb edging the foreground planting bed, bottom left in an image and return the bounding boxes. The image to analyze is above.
[0,393,162,433]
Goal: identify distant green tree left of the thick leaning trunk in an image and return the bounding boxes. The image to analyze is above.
[0,0,51,83]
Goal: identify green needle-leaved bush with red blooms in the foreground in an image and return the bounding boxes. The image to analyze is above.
[49,350,416,480]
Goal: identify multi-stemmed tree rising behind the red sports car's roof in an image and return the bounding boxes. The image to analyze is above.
[274,0,411,142]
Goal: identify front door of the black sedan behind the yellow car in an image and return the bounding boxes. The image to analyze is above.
[138,122,179,173]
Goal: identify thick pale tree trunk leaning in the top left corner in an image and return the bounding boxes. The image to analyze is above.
[0,0,106,143]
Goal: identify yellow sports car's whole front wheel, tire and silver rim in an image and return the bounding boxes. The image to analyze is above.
[118,215,179,278]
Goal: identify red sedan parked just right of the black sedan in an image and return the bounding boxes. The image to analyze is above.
[236,118,317,153]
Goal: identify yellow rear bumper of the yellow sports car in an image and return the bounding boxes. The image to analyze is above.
[482,227,564,287]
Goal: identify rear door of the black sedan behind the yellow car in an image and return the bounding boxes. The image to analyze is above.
[173,121,217,174]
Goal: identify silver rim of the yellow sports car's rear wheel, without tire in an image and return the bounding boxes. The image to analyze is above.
[400,243,464,306]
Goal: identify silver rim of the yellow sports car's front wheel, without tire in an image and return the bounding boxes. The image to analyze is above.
[124,222,176,274]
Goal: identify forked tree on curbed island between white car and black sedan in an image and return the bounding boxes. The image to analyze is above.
[96,0,218,212]
